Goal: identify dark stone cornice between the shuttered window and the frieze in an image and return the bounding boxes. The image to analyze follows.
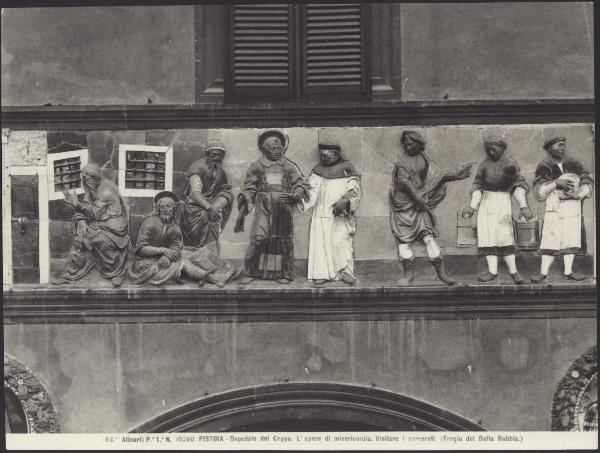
[2,99,595,130]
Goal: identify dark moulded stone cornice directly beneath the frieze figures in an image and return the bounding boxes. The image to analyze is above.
[3,284,596,324]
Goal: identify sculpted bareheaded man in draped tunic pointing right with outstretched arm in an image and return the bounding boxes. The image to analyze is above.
[389,131,472,285]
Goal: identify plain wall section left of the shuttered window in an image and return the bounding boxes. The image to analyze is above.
[2,5,194,105]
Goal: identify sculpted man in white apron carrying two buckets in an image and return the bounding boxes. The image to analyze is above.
[462,136,533,284]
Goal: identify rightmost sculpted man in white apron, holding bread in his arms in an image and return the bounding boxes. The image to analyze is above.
[531,136,593,283]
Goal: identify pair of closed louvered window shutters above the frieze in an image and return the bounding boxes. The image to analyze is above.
[227,3,370,102]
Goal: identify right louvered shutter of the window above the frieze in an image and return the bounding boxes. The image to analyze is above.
[302,3,367,95]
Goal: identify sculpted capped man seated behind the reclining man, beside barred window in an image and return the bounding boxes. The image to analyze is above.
[181,140,233,248]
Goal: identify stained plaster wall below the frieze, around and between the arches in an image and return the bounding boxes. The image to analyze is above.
[4,318,596,433]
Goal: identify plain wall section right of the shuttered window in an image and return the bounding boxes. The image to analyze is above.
[398,2,594,102]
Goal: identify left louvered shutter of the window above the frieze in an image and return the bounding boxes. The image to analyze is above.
[228,4,295,101]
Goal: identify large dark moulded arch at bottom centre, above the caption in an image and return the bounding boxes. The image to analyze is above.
[132,383,484,433]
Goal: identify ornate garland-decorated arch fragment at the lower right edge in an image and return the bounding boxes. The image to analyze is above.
[552,346,598,431]
